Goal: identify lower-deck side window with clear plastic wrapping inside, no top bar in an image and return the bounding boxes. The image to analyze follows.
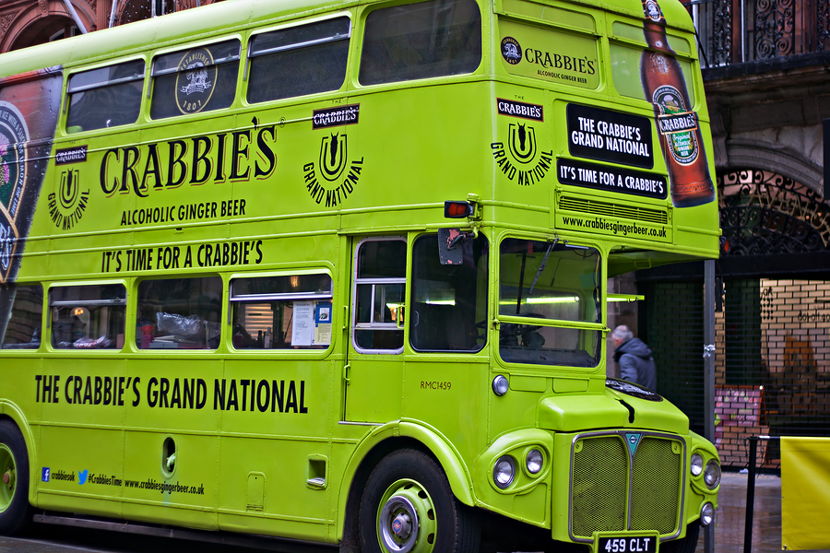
[136,276,222,349]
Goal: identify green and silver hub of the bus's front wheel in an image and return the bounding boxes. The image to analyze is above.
[377,478,438,553]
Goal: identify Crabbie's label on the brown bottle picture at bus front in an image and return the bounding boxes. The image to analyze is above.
[652,85,700,165]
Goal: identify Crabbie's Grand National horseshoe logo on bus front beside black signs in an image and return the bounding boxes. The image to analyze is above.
[490,99,553,186]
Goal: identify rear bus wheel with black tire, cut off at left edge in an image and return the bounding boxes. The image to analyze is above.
[0,420,31,536]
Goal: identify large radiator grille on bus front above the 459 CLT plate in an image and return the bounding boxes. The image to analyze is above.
[570,434,685,541]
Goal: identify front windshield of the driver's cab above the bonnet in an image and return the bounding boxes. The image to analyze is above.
[499,238,602,367]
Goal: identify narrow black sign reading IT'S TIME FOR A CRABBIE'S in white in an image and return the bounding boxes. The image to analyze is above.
[556,158,669,200]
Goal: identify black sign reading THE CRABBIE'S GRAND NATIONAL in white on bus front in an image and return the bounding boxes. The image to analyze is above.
[567,104,654,169]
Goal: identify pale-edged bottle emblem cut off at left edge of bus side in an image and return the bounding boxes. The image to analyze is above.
[0,101,29,276]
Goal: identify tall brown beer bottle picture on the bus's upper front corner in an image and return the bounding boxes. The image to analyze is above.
[640,0,715,207]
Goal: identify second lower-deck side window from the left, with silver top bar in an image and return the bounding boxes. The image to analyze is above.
[49,284,127,349]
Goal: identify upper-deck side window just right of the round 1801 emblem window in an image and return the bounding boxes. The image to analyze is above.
[248,17,351,103]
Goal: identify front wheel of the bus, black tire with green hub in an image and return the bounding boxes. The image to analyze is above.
[358,449,481,553]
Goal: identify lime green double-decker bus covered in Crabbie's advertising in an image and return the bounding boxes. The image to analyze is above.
[0,0,720,553]
